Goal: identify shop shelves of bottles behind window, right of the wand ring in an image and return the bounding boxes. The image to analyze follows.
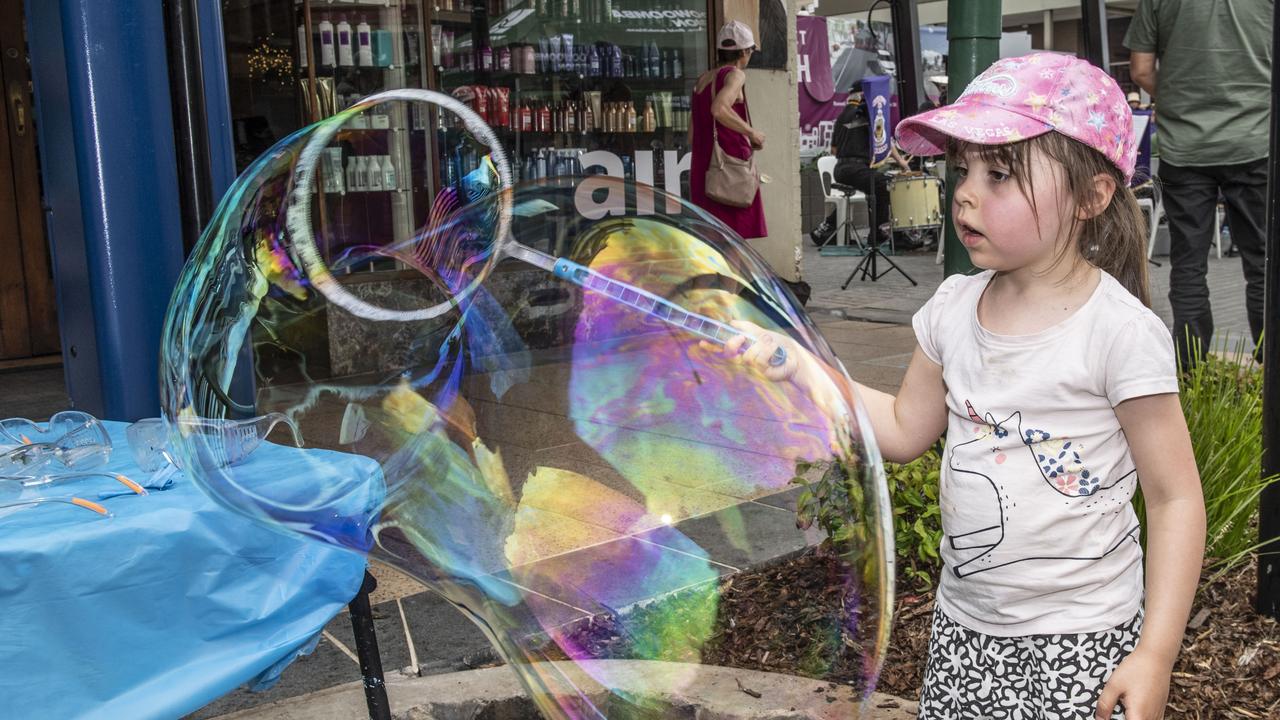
[430,0,708,188]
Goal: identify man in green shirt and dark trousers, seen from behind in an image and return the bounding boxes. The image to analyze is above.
[1124,0,1275,368]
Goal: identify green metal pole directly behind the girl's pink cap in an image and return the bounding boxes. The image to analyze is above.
[942,0,1001,275]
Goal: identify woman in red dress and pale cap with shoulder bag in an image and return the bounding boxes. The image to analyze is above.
[689,20,768,238]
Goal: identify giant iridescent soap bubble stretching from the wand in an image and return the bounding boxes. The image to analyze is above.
[161,91,892,717]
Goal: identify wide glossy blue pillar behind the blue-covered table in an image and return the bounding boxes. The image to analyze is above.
[27,0,183,420]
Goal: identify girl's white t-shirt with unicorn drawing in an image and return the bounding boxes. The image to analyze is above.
[913,270,1178,637]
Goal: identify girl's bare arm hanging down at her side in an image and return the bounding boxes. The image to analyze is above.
[1097,393,1204,720]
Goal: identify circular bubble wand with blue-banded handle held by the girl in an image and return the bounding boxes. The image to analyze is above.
[287,88,787,366]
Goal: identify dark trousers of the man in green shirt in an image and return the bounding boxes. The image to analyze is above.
[1158,158,1267,368]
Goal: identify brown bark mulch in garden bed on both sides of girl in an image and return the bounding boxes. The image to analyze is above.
[545,553,1280,720]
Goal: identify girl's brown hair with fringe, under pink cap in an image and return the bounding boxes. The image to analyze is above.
[947,132,1151,302]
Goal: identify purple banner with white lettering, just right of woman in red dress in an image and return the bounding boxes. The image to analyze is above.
[796,15,849,158]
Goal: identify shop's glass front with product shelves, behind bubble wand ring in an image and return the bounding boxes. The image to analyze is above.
[223,0,709,273]
